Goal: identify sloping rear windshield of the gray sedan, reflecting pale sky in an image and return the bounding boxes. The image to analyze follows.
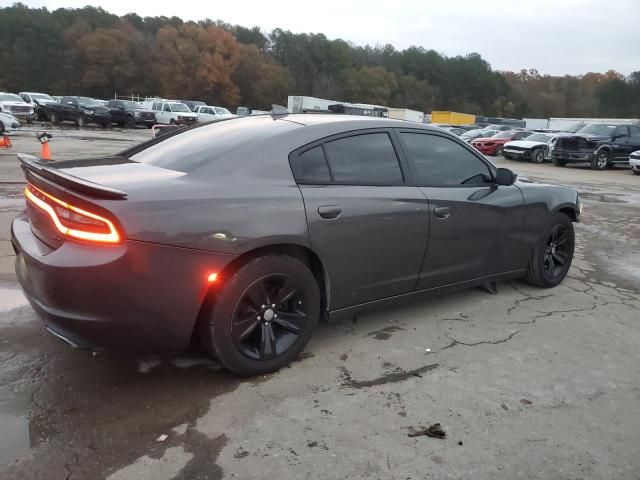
[130,116,300,173]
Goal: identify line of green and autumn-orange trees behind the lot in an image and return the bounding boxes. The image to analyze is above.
[0,3,640,118]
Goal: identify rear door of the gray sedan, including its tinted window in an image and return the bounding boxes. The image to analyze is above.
[290,130,429,310]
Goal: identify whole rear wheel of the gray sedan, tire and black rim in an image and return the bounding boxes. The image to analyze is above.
[202,255,320,376]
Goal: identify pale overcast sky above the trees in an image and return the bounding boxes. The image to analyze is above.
[10,0,640,75]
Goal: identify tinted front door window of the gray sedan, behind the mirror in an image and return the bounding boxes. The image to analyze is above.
[400,133,491,186]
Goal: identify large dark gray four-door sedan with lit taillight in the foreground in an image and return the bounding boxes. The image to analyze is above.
[11,114,581,375]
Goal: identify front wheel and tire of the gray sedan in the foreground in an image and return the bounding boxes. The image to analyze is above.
[525,212,575,288]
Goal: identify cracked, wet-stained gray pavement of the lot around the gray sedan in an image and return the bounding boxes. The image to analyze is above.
[0,131,640,480]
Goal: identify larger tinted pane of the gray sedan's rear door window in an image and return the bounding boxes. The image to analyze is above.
[325,133,403,185]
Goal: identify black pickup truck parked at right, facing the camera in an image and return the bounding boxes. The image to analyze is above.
[552,123,640,170]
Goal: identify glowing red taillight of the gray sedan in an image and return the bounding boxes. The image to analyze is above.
[24,183,122,245]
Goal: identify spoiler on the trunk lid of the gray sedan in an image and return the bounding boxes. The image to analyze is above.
[18,153,127,200]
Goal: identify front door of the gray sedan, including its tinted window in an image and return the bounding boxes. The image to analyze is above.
[398,130,529,290]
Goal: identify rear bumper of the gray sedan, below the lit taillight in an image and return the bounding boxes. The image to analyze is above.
[11,213,233,352]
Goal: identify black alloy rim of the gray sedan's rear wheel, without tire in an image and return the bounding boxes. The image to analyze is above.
[231,273,308,360]
